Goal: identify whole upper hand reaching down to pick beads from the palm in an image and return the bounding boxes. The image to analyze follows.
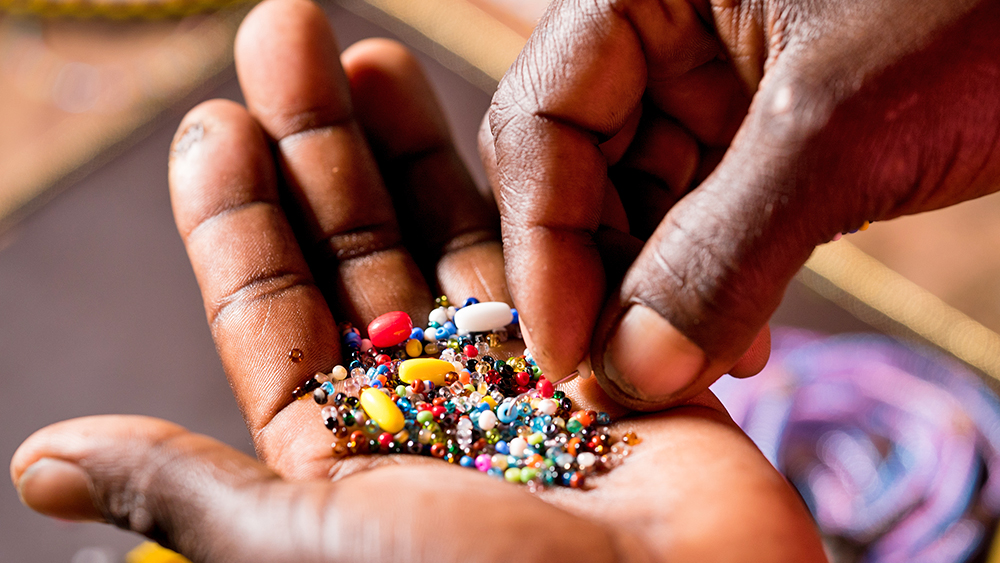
[481,0,1000,410]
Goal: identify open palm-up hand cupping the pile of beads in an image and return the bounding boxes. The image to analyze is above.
[11,0,825,563]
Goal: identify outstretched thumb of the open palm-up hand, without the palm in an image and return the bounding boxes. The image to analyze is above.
[11,416,280,562]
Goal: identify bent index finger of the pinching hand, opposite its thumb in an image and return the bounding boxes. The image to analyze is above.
[490,1,719,379]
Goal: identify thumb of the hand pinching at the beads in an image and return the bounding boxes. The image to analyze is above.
[591,69,862,410]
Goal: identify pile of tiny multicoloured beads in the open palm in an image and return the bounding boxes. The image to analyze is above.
[293,297,640,490]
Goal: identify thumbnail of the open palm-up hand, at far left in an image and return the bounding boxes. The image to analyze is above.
[17,457,103,521]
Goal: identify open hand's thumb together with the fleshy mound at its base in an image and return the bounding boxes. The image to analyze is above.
[11,416,648,563]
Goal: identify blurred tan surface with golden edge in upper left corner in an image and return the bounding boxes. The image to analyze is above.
[0,10,242,234]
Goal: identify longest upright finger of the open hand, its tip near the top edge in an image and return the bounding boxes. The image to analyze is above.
[236,0,433,325]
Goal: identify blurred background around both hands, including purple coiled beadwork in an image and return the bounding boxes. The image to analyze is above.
[0,0,1000,563]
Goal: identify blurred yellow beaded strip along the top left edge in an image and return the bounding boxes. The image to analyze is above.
[0,0,257,20]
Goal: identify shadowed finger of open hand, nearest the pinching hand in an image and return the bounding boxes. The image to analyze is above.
[341,39,510,303]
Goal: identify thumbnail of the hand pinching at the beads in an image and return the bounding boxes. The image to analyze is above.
[604,305,706,402]
